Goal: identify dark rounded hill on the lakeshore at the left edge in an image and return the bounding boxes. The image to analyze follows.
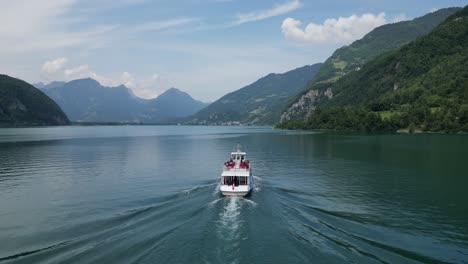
[0,74,69,126]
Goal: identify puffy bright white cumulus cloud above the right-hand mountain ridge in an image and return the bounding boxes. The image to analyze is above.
[281,13,388,43]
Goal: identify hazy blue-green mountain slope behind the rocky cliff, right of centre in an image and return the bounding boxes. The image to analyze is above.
[191,63,321,124]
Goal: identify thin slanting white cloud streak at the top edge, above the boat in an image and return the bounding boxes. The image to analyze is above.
[234,0,302,25]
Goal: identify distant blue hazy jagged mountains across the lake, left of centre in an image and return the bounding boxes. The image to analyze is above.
[42,78,206,123]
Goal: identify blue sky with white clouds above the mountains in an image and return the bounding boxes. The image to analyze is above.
[0,0,468,102]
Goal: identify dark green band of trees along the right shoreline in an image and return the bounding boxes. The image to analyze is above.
[277,104,468,133]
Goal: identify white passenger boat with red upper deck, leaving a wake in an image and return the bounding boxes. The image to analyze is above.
[219,144,253,197]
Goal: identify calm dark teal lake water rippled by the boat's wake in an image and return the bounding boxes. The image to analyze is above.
[0,126,468,263]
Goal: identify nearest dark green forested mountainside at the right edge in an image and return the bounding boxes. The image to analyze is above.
[281,6,468,132]
